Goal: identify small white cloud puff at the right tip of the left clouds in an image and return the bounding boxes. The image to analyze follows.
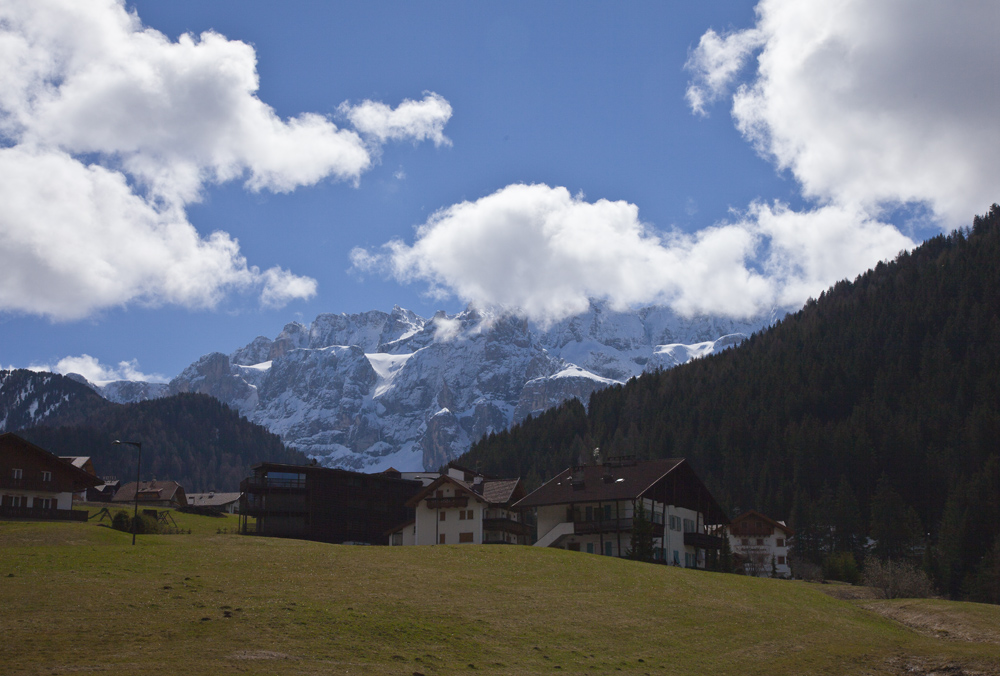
[339,92,451,146]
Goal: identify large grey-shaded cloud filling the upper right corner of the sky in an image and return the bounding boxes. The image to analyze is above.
[688,0,1000,228]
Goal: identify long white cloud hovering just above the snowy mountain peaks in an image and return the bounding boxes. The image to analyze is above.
[351,185,912,322]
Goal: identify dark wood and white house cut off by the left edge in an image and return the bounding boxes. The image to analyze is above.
[0,432,101,521]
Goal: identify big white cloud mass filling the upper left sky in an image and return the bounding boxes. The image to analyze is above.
[0,0,450,319]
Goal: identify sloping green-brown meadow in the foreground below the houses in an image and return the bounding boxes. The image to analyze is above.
[0,514,1000,676]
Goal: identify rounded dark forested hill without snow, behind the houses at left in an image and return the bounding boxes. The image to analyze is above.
[17,386,308,492]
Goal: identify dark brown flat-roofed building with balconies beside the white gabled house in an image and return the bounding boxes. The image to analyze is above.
[240,462,423,545]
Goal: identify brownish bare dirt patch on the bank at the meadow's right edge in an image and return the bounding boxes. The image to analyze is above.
[861,599,1000,645]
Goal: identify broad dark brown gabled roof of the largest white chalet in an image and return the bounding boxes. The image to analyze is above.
[514,458,729,523]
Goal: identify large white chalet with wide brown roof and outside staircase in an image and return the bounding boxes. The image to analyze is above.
[515,458,729,568]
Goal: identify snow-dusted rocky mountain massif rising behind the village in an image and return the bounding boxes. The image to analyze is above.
[95,303,774,471]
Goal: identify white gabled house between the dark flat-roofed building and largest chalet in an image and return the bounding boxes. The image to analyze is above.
[389,463,531,545]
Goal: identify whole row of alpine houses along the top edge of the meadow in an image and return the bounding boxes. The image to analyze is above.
[0,433,794,577]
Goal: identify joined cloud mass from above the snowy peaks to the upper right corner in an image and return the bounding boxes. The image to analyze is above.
[353,0,1000,320]
